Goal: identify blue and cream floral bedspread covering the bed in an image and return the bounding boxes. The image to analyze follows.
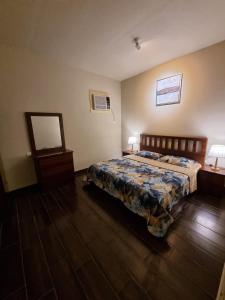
[87,157,190,237]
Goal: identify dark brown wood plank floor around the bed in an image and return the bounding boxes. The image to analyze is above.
[0,177,225,300]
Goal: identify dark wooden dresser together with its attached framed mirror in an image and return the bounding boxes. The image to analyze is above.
[25,112,74,190]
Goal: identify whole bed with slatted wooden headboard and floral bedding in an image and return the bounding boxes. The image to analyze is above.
[87,134,207,237]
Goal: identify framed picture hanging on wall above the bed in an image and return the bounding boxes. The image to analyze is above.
[156,74,183,106]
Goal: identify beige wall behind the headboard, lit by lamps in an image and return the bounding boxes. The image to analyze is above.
[121,42,225,166]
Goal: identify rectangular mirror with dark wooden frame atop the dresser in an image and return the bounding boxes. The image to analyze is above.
[25,112,65,154]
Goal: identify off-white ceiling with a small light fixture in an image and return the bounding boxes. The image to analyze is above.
[0,0,225,80]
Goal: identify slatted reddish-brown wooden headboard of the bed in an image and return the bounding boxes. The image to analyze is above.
[140,134,208,166]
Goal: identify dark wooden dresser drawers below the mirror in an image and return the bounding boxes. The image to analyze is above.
[33,150,74,190]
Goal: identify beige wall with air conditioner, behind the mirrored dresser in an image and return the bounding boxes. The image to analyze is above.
[0,46,121,190]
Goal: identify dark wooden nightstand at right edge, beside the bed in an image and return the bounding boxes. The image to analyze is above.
[198,165,225,197]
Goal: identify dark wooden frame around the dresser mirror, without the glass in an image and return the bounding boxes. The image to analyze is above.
[25,112,66,155]
